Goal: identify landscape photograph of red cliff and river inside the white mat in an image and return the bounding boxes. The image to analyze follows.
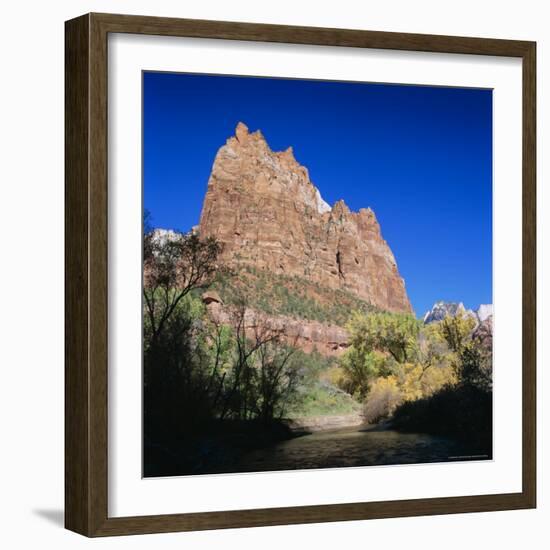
[142,71,494,478]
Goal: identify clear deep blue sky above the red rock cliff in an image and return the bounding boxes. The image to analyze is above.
[143,72,492,315]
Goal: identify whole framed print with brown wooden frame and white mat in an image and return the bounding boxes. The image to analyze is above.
[65,14,536,536]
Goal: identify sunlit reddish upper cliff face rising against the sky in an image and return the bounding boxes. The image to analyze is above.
[199,123,411,312]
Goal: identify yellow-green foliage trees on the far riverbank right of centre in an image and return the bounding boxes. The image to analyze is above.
[340,313,468,422]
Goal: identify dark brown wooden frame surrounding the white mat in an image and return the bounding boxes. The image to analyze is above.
[65,13,536,536]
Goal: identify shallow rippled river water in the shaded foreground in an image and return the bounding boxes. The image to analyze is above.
[232,427,489,472]
